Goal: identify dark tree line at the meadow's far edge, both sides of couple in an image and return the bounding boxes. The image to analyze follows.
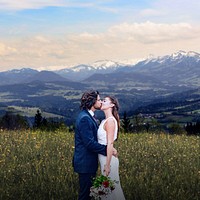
[0,109,200,135]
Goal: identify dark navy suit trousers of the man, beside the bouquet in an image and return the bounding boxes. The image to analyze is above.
[78,173,96,200]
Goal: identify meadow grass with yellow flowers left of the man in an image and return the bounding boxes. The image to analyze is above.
[0,131,78,199]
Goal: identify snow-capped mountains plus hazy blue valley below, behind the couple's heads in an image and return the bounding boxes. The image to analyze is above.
[0,51,200,122]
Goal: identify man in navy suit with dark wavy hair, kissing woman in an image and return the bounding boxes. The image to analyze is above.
[73,90,117,200]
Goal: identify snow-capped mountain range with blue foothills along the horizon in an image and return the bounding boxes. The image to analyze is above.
[0,51,200,87]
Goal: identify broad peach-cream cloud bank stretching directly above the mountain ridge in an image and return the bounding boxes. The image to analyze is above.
[0,22,200,68]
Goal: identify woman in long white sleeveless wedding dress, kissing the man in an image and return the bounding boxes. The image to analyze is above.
[97,96,125,200]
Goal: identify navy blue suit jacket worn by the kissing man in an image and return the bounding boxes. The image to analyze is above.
[73,110,106,173]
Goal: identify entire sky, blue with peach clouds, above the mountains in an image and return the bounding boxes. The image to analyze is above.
[0,0,200,71]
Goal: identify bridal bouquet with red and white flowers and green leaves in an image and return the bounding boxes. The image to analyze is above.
[90,175,117,199]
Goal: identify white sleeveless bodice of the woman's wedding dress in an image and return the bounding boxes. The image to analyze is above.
[97,117,118,145]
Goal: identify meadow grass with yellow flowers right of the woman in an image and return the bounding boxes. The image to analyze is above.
[118,134,200,200]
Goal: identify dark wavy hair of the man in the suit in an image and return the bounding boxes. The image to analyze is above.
[80,90,99,110]
